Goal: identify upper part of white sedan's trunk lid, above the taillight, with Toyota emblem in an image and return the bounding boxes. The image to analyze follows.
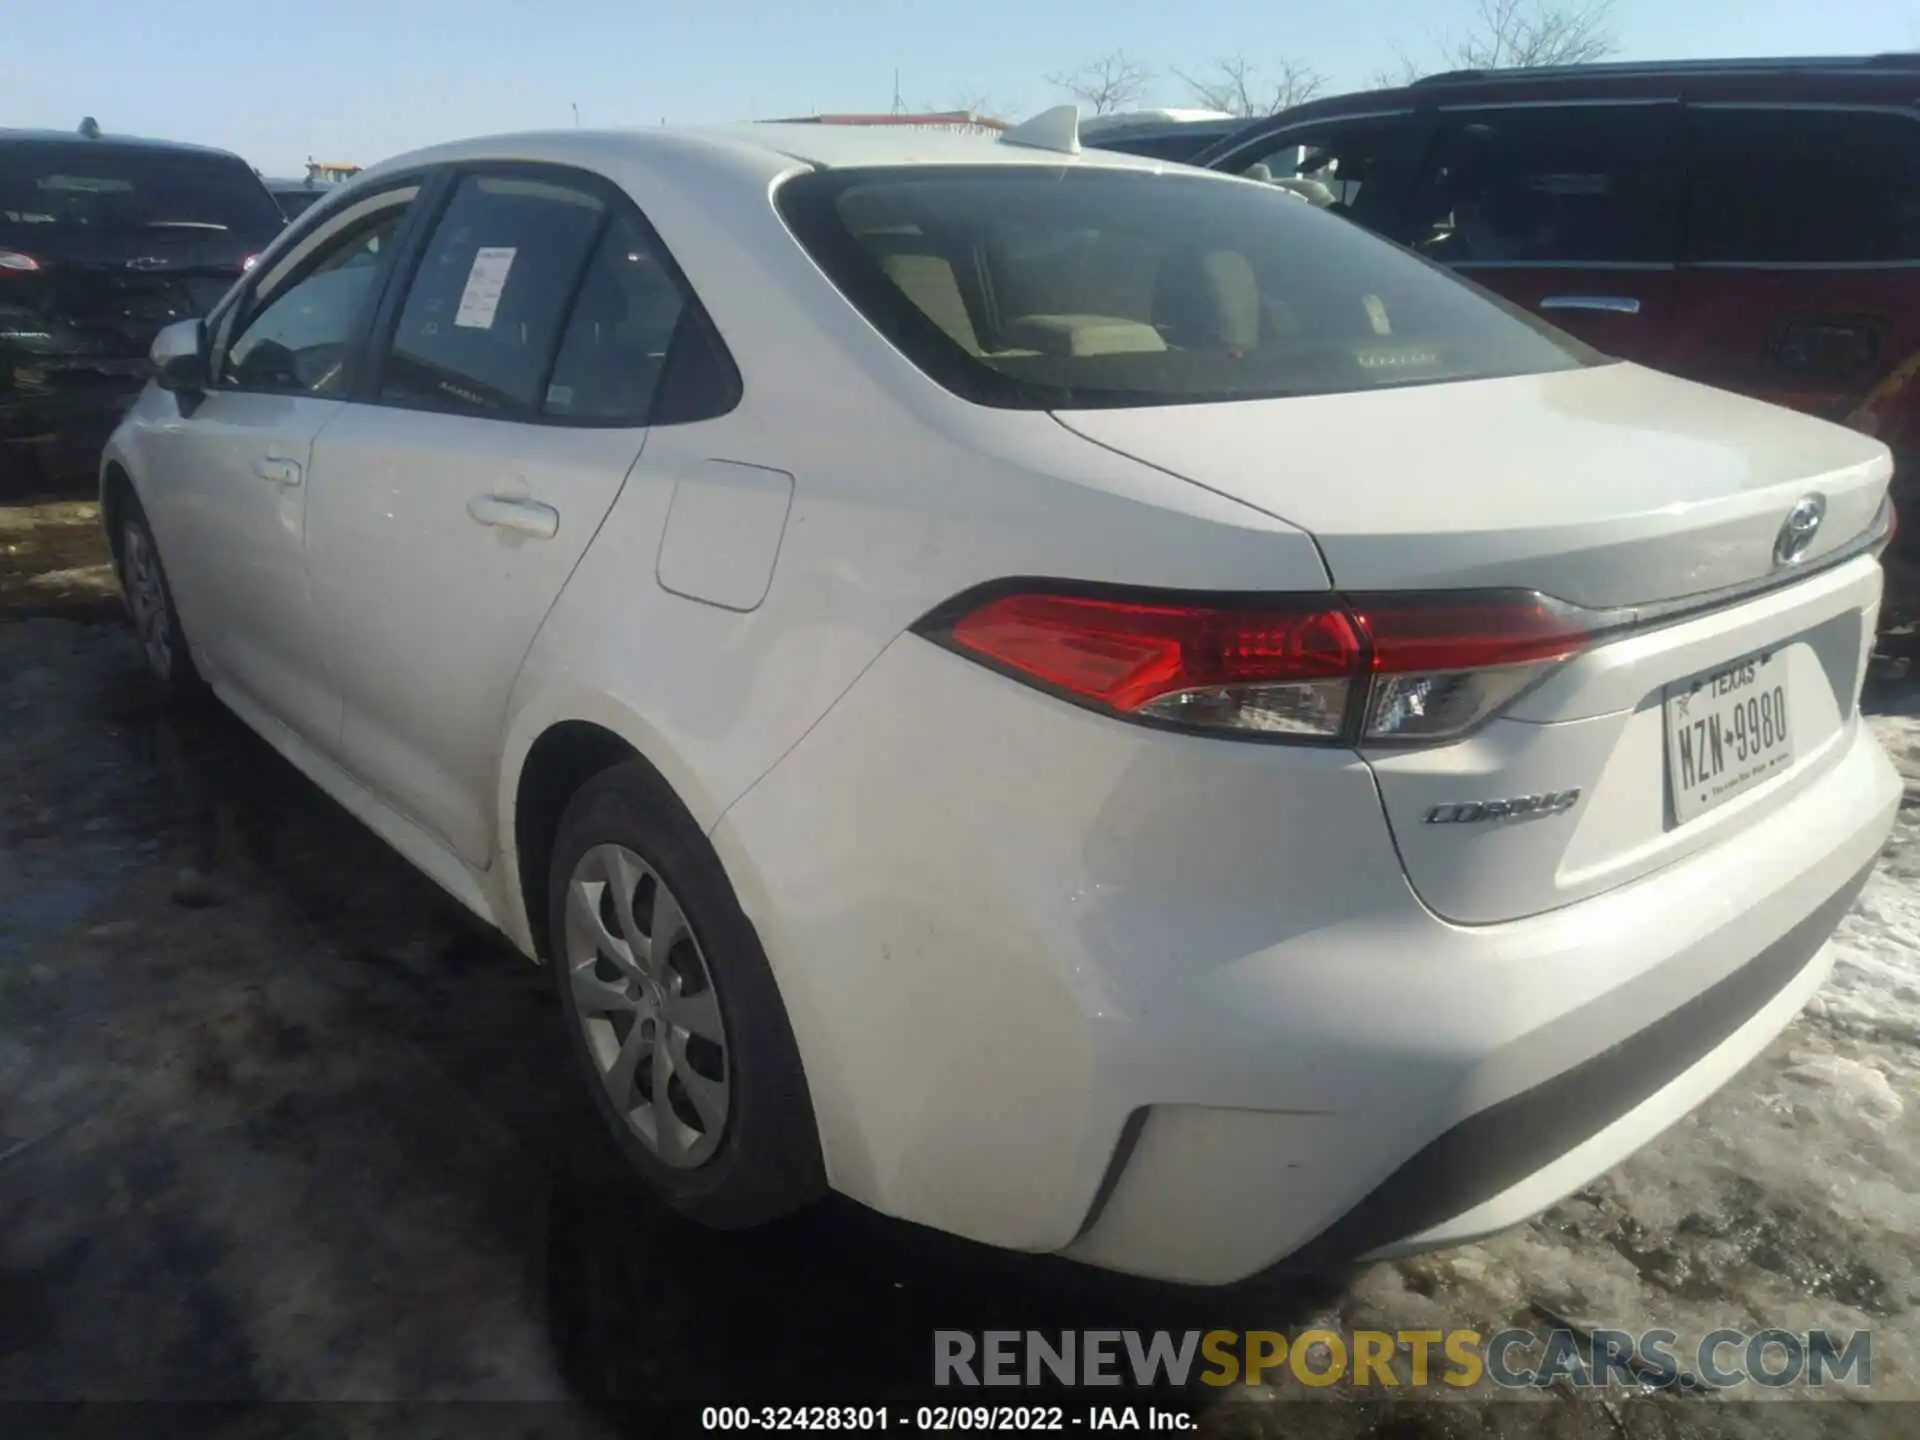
[1056,365,1889,609]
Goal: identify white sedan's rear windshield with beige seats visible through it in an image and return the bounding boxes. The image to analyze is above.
[778,165,1599,409]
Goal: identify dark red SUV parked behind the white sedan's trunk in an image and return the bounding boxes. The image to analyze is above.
[1194,56,1920,540]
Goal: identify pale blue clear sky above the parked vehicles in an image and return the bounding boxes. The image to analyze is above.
[0,0,1920,175]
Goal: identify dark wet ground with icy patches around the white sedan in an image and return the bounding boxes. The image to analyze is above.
[0,503,1920,1436]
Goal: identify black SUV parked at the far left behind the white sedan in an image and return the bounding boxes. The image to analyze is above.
[0,121,282,486]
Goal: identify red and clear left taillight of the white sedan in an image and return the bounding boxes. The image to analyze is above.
[916,588,1594,743]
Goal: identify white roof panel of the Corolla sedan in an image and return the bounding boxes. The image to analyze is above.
[353,123,1228,184]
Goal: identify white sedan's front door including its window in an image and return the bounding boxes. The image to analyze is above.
[150,188,415,753]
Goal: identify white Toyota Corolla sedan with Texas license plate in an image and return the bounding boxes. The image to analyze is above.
[102,113,1899,1283]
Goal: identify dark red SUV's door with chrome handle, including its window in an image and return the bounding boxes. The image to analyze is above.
[1396,100,1682,365]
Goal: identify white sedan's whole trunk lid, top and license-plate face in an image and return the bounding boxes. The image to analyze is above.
[1058,365,1891,924]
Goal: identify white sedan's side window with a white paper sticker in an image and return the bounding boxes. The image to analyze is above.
[380,175,607,419]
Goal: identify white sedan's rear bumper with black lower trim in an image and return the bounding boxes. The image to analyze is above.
[714,637,1901,1284]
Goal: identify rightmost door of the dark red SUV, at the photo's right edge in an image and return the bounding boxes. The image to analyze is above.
[1670,104,1920,442]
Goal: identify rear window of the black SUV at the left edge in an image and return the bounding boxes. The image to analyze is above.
[0,142,282,236]
